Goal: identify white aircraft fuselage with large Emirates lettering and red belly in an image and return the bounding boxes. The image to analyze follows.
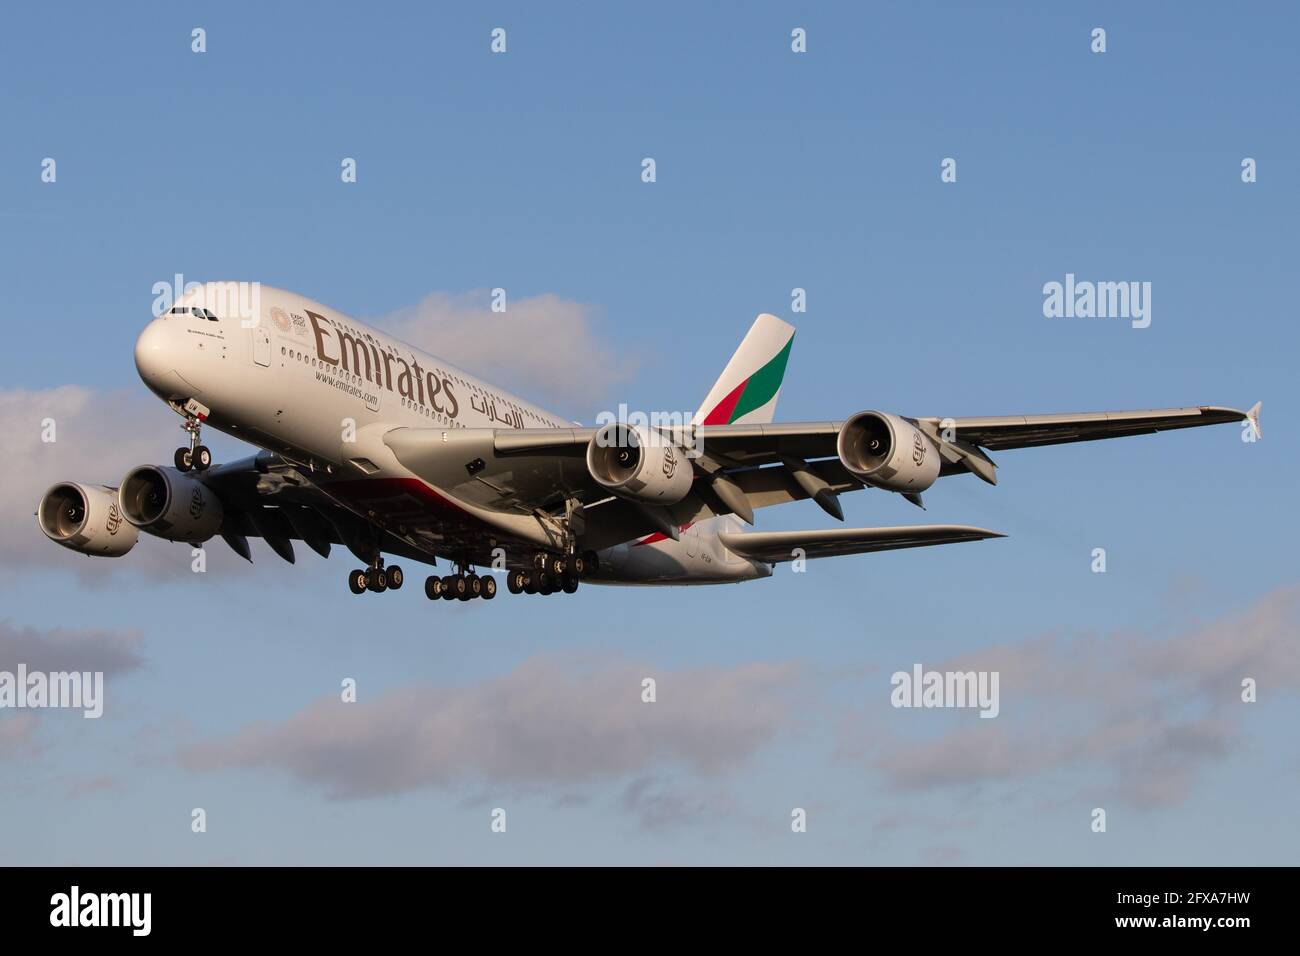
[135,282,771,584]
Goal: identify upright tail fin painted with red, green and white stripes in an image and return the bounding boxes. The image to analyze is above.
[692,312,794,425]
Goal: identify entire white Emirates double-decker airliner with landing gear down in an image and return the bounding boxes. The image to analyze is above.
[36,284,1260,600]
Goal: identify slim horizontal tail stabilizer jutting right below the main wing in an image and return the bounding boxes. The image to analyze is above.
[718,524,1006,564]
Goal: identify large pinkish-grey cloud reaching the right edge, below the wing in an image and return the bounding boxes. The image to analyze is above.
[841,587,1300,806]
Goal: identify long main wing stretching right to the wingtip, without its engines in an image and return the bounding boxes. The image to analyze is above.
[384,405,1260,549]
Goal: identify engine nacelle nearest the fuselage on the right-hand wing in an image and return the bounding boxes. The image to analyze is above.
[586,421,696,505]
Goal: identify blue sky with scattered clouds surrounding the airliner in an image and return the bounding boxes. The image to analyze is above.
[0,3,1300,864]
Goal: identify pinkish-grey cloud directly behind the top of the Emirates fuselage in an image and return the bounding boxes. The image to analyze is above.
[368,289,634,416]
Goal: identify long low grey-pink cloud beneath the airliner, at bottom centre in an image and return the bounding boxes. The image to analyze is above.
[179,657,797,799]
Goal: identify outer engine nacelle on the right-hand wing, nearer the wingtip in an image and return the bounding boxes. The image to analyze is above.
[835,411,941,493]
